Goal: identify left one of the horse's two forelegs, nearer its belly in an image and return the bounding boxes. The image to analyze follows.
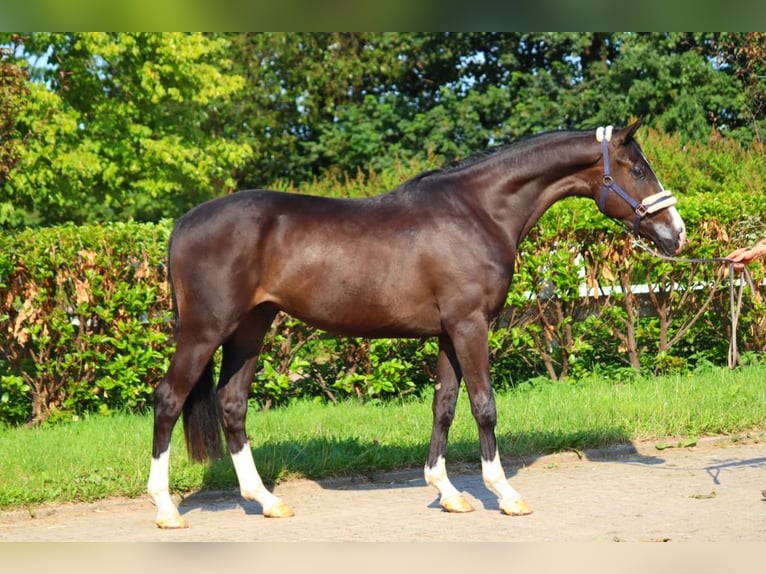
[424,336,473,512]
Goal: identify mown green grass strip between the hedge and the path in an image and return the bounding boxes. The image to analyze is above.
[0,363,766,508]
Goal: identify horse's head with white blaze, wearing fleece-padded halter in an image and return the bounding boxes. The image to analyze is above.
[596,120,686,255]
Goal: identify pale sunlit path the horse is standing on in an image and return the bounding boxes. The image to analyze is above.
[0,439,766,542]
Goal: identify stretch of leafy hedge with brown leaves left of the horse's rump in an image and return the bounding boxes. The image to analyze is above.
[0,224,171,422]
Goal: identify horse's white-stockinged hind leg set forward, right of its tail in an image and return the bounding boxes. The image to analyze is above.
[218,307,293,518]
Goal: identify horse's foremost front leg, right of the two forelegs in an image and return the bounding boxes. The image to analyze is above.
[453,320,532,515]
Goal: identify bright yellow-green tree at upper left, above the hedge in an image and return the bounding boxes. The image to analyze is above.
[0,33,250,225]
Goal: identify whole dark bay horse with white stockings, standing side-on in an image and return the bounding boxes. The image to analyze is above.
[148,122,685,528]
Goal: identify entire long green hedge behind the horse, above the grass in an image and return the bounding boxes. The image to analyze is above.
[0,132,766,424]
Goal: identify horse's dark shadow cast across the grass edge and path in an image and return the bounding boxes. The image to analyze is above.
[179,429,664,514]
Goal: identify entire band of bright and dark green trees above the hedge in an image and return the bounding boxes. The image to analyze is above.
[0,32,766,228]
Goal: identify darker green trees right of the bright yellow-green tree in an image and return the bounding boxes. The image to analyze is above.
[224,32,746,187]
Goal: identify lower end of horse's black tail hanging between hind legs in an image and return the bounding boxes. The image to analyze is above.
[183,360,223,462]
